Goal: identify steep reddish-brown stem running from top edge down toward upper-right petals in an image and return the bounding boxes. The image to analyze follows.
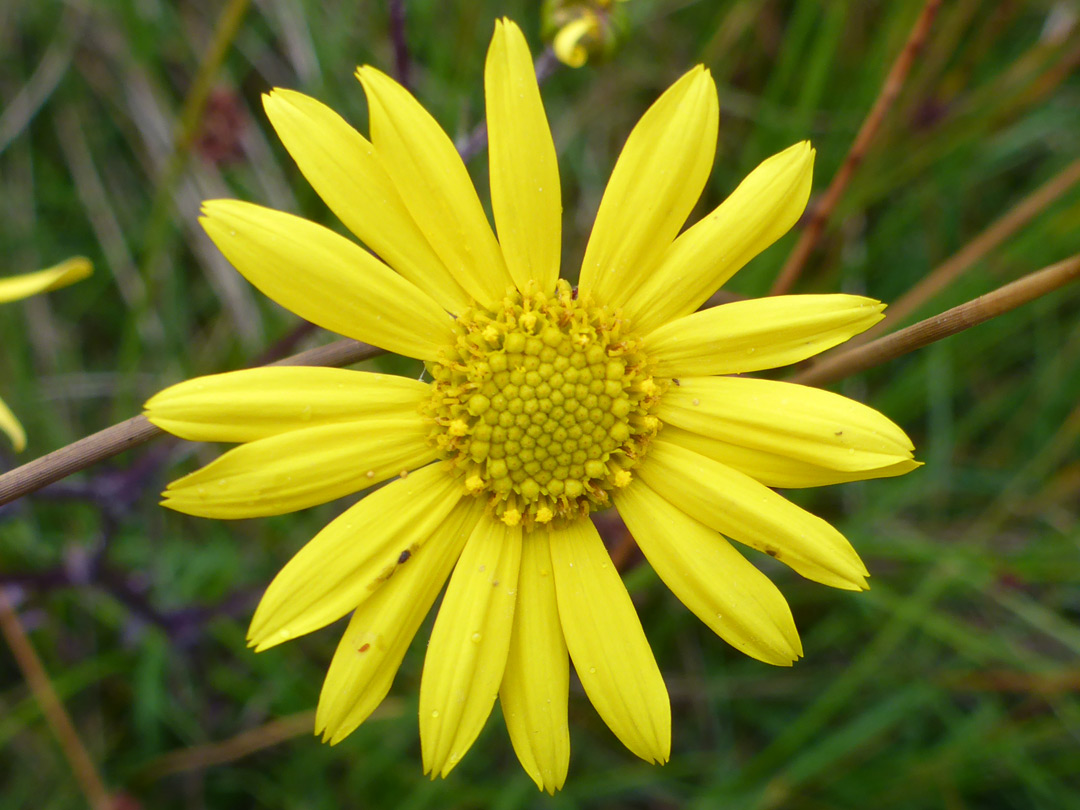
[770,0,941,295]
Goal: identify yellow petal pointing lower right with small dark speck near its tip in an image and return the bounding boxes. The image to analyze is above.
[635,441,867,591]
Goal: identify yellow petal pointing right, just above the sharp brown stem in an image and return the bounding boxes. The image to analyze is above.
[646,295,885,377]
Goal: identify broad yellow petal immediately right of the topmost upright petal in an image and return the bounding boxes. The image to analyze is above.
[579,65,719,307]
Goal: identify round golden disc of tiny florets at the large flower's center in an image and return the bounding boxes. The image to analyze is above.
[426,280,661,527]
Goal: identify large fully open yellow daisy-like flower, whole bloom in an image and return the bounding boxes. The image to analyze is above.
[147,21,916,792]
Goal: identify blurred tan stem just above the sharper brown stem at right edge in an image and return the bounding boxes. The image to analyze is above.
[851,159,1080,345]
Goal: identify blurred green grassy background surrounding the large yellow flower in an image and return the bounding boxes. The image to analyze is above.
[0,0,1080,810]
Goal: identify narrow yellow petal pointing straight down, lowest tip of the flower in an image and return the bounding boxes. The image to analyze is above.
[499,530,570,794]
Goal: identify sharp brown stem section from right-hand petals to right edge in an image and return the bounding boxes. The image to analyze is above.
[791,254,1080,386]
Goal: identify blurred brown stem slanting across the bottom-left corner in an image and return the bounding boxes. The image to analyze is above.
[0,588,112,810]
